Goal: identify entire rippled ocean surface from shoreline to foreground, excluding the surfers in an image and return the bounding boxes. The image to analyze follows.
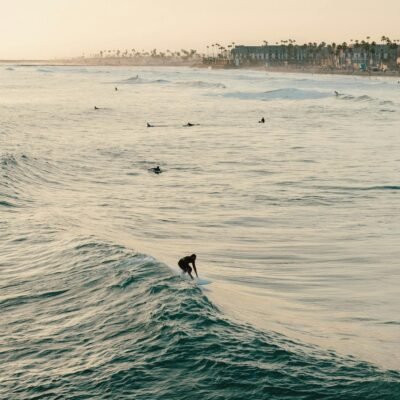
[0,65,400,400]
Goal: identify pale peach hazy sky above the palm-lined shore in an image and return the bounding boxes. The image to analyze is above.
[0,0,400,59]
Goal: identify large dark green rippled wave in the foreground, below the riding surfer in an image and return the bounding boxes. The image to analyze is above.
[0,237,400,400]
